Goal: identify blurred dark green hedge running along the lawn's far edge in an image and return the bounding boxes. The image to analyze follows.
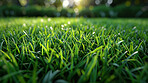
[0,4,148,18]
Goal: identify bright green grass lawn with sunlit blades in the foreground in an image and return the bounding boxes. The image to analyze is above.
[0,18,148,83]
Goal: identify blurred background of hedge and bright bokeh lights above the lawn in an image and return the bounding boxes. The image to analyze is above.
[0,0,148,18]
